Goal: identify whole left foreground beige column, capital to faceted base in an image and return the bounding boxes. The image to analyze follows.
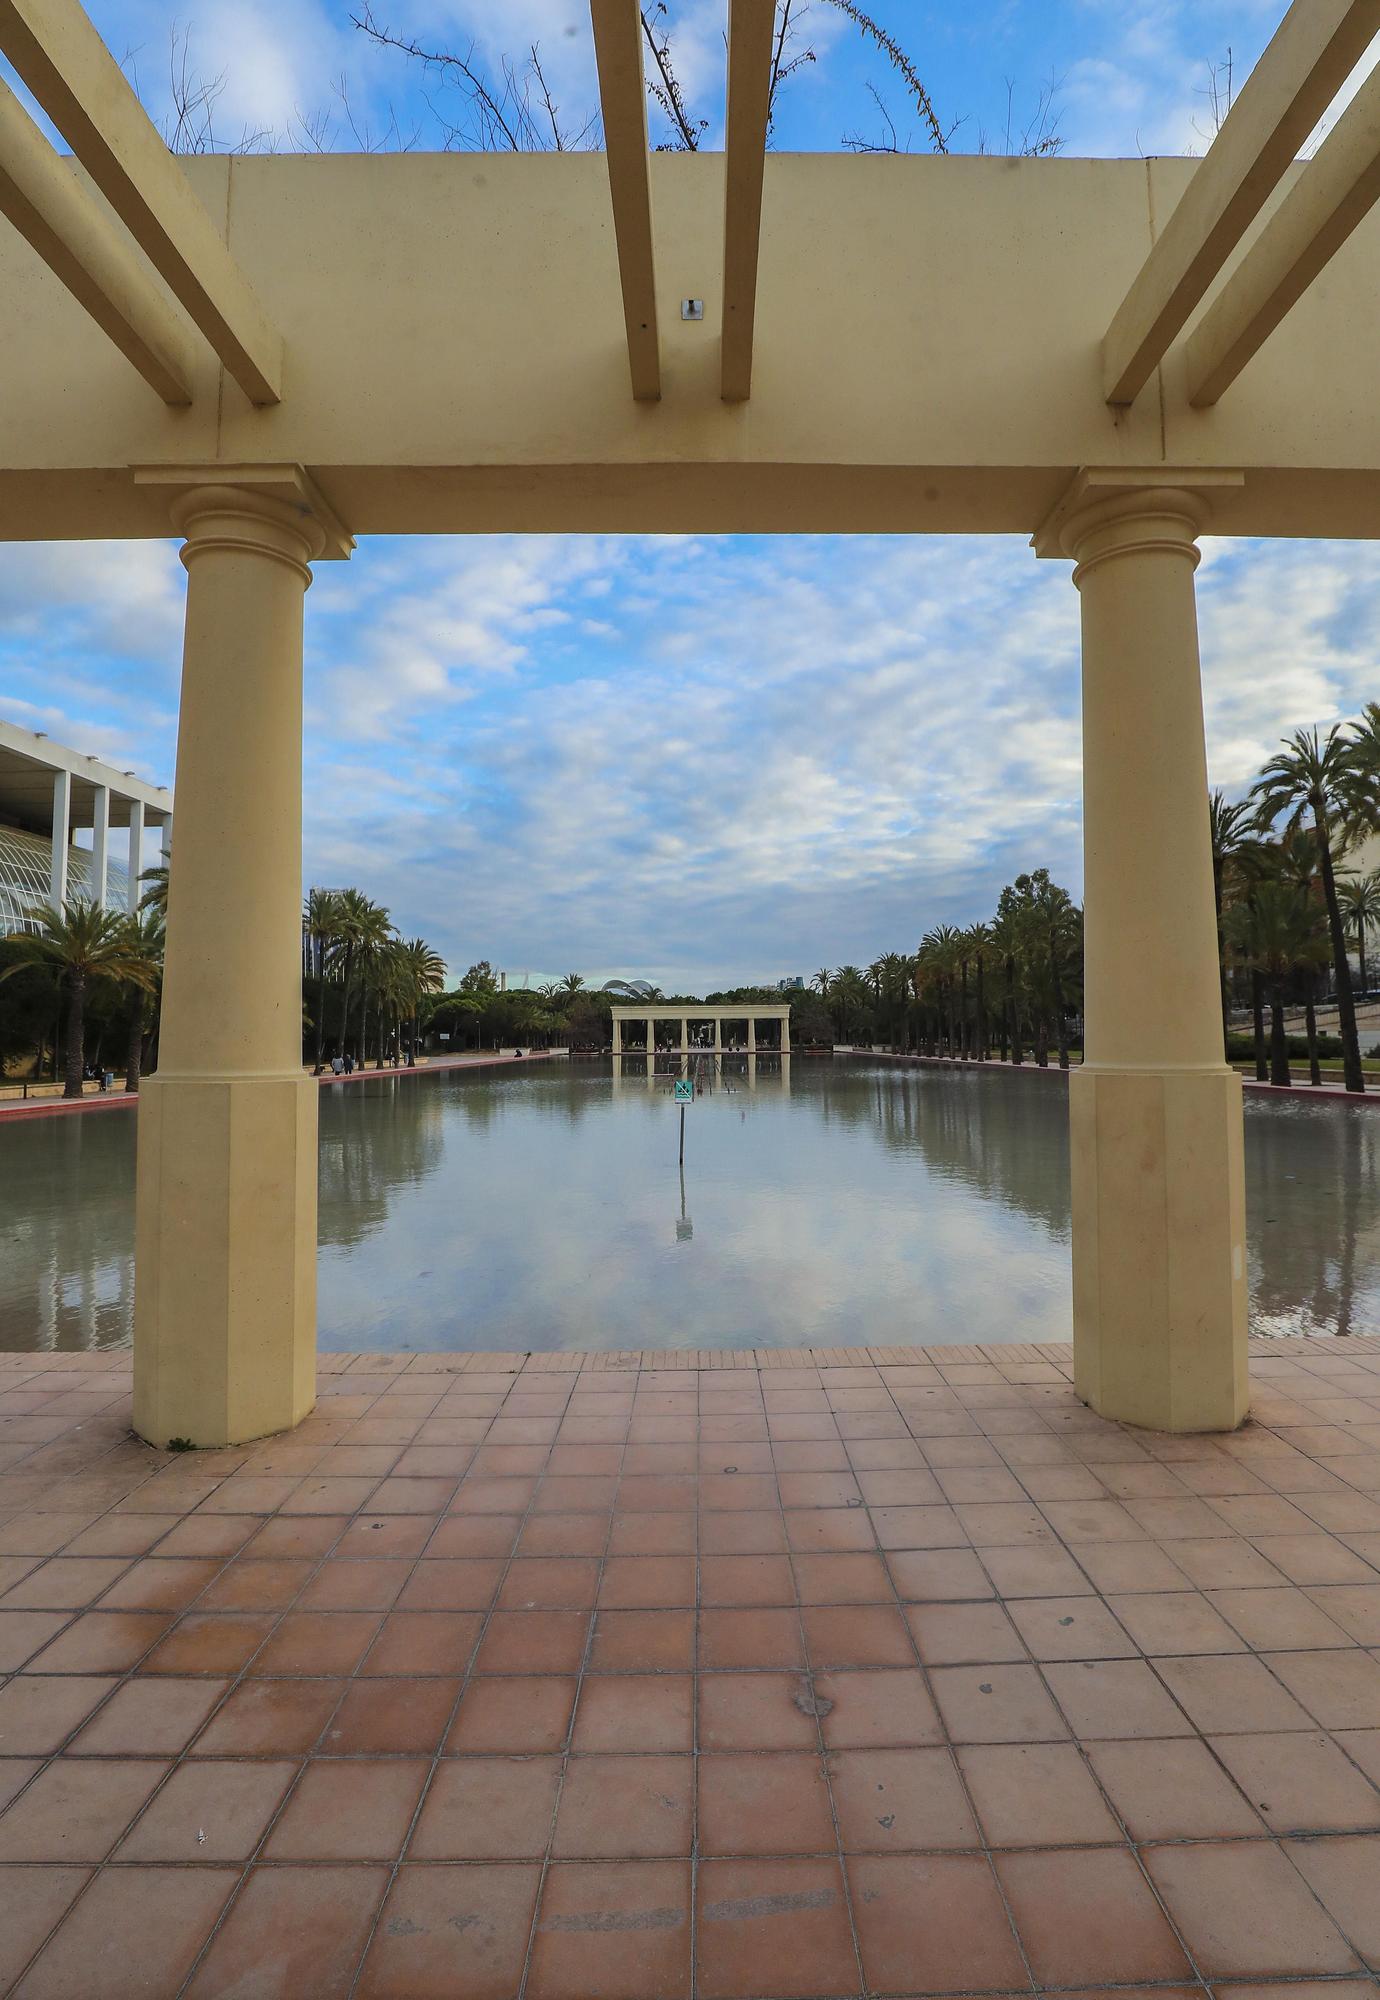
[134,486,322,1446]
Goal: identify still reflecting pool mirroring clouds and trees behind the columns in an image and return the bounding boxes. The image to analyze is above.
[0,1056,1380,1350]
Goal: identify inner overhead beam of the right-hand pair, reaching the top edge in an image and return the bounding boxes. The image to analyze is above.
[1102,0,1380,404]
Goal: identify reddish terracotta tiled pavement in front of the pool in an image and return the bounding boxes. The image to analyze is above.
[0,1338,1380,2000]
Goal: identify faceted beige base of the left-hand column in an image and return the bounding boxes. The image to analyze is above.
[134,1076,320,1446]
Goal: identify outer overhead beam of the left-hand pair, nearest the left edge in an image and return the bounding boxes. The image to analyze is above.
[0,80,192,406]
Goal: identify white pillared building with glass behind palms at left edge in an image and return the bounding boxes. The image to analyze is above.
[0,722,172,932]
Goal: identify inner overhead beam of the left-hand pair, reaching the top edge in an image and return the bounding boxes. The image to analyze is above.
[0,0,282,404]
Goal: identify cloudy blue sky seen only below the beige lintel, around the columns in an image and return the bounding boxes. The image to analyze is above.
[0,516,1380,990]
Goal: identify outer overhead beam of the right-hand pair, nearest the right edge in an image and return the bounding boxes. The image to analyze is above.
[1188,58,1380,410]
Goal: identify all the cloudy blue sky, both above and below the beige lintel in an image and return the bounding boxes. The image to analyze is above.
[0,0,1380,990]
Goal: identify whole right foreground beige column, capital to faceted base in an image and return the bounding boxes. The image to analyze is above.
[1060,486,1246,1432]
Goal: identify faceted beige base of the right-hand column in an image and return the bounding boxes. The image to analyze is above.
[1068,1066,1248,1432]
